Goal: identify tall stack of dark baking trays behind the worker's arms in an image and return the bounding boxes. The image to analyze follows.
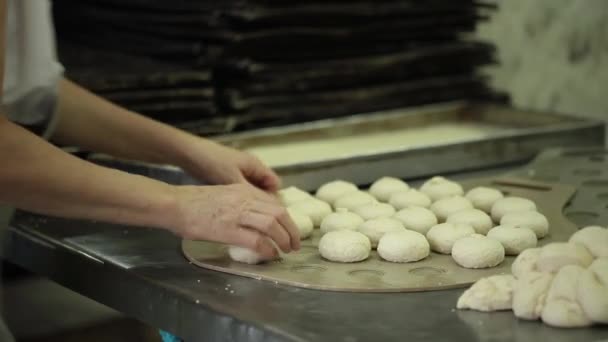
[55,0,506,133]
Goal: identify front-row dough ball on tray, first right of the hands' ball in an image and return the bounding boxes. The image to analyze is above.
[319,230,372,262]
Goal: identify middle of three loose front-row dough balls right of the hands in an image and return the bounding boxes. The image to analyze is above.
[378,230,431,262]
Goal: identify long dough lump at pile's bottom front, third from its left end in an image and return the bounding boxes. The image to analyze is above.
[541,265,591,328]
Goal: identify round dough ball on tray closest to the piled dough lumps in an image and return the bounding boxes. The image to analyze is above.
[452,234,505,268]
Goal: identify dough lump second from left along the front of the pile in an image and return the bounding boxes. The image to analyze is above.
[513,270,553,320]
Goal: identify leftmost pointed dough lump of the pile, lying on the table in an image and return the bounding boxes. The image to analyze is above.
[456,274,515,312]
